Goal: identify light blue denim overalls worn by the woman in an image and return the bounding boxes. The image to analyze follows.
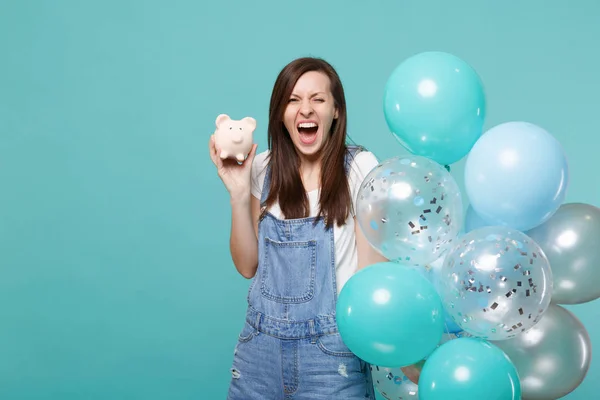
[227,146,375,400]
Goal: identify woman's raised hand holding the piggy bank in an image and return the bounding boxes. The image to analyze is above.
[208,135,257,198]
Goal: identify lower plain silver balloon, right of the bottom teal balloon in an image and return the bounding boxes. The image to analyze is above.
[493,304,592,400]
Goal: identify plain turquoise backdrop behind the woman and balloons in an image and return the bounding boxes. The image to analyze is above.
[0,0,600,400]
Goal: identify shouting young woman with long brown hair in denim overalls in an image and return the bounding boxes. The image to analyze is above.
[209,57,385,400]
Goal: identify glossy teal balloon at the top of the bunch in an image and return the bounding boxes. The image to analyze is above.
[383,52,486,165]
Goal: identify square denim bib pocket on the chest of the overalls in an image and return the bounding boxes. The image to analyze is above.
[261,237,317,303]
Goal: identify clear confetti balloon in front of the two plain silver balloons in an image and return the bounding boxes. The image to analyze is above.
[436,226,552,340]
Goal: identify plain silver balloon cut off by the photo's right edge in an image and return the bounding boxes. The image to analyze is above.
[526,203,600,304]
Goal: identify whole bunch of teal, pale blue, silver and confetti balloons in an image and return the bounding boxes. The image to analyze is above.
[337,52,600,400]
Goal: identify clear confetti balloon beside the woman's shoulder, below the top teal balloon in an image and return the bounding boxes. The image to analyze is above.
[356,155,463,265]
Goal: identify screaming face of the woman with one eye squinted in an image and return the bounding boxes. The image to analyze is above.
[283,71,338,157]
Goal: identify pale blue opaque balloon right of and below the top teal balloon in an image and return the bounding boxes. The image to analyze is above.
[465,122,569,231]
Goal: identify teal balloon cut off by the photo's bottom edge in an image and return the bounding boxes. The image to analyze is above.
[419,337,521,400]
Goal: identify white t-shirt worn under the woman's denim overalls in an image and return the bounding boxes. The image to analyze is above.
[252,150,379,293]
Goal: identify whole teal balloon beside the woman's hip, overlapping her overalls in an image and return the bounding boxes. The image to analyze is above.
[336,262,444,368]
